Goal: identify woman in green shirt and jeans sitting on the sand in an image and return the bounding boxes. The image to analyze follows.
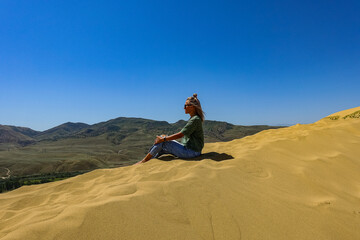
[136,93,204,164]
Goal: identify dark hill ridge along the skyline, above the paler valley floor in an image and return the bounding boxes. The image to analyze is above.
[0,117,282,146]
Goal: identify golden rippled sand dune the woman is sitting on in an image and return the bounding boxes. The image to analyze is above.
[0,107,360,240]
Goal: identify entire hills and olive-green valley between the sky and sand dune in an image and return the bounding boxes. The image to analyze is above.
[0,117,279,176]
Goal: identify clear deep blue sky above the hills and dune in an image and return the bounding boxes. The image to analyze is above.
[0,0,360,130]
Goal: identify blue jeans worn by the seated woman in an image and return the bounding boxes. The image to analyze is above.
[149,140,201,158]
